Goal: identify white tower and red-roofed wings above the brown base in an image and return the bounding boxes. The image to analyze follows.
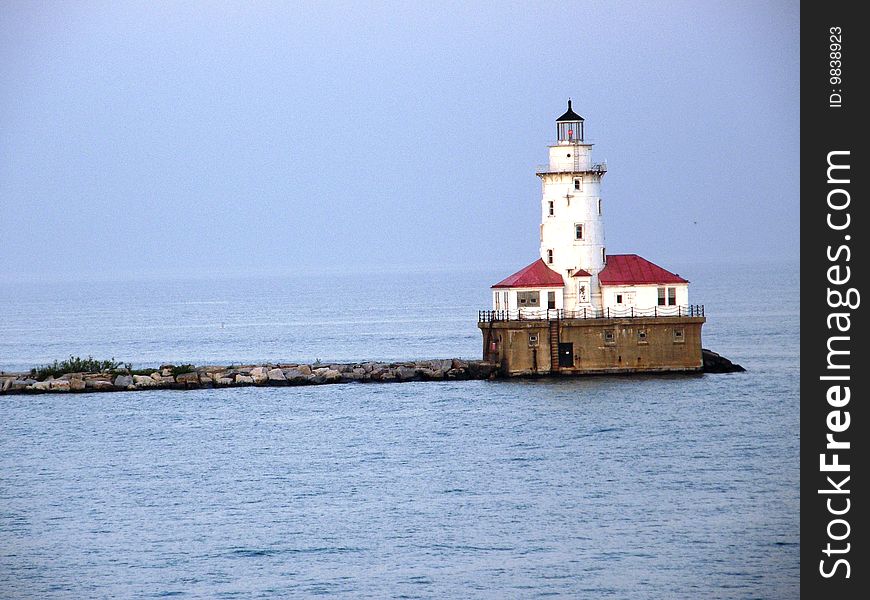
[492,100,689,318]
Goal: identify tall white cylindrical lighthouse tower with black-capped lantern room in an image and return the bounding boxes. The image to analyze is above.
[537,100,607,310]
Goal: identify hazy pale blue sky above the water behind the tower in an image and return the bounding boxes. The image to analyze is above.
[0,0,800,281]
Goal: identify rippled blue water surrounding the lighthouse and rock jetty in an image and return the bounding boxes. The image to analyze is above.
[0,264,800,598]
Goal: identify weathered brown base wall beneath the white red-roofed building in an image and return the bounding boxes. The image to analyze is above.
[479,317,705,375]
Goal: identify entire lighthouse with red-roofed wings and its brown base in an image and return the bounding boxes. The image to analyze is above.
[478,99,706,374]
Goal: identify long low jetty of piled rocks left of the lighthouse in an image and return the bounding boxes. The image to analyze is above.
[0,358,498,394]
